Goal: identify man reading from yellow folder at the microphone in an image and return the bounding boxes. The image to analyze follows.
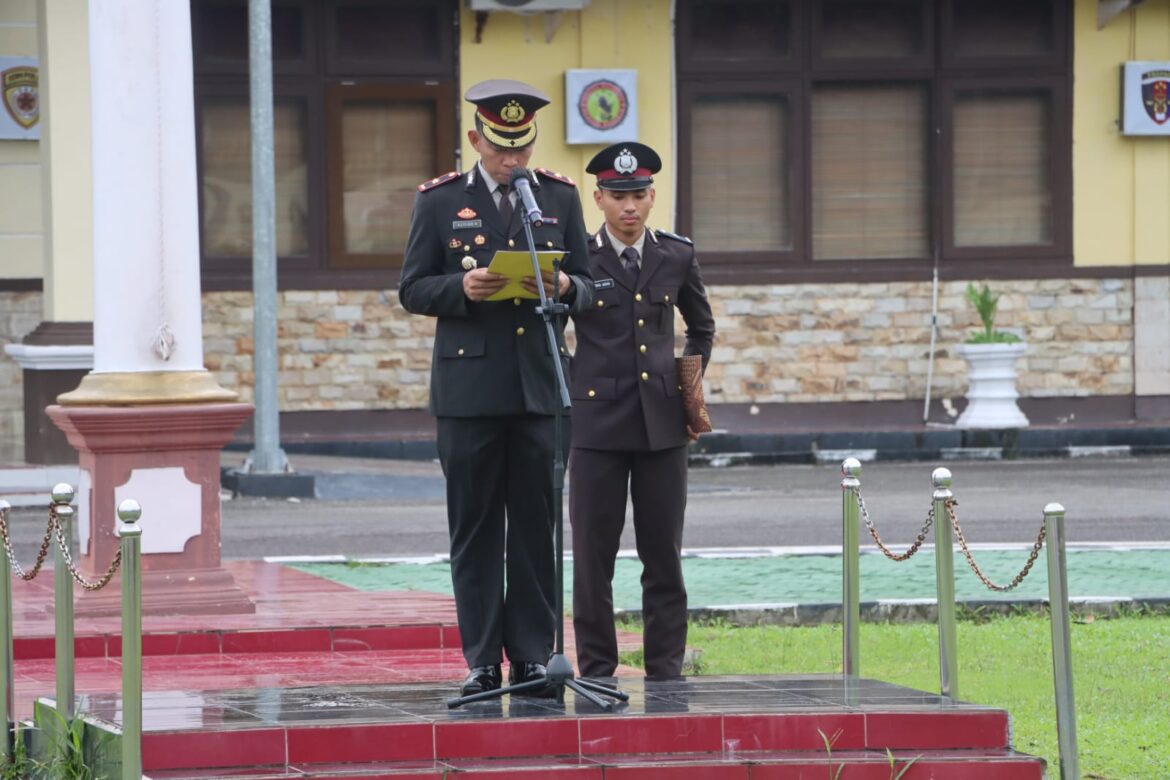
[398,80,593,696]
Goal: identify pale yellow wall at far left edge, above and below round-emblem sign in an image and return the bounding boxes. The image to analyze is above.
[0,0,43,279]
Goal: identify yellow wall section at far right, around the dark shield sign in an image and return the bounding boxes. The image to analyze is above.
[1073,0,1170,265]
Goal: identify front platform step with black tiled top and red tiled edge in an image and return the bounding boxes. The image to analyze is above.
[66,675,1044,780]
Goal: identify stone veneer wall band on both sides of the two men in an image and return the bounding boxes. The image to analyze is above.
[204,278,1134,410]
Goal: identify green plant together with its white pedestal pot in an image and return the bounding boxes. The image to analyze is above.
[956,282,1028,428]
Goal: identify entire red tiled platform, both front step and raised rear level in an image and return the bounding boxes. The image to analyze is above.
[14,561,1044,780]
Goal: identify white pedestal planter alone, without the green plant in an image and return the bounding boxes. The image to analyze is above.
[955,341,1027,428]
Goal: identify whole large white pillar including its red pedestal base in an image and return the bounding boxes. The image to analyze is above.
[46,0,255,615]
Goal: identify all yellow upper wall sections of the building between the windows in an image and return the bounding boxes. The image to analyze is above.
[0,0,1170,278]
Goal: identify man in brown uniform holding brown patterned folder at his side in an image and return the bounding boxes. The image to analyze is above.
[569,143,715,678]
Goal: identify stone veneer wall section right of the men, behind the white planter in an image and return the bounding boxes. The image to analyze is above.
[707,279,1134,402]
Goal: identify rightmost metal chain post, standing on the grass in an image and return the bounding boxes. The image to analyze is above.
[1044,503,1081,780]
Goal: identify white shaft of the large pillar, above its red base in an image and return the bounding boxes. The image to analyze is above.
[89,0,204,373]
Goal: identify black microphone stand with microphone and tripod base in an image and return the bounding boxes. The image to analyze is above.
[447,177,629,711]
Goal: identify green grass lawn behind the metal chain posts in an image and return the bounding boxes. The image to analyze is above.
[621,615,1170,780]
